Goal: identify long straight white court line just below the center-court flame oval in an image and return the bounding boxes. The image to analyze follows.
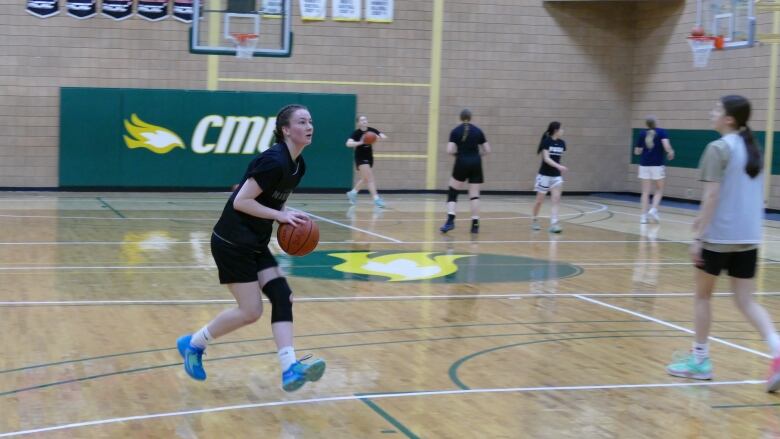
[0,291,780,306]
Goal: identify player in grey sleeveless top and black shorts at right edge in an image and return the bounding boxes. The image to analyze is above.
[666,95,780,392]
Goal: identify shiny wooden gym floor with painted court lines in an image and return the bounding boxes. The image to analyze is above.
[0,193,780,438]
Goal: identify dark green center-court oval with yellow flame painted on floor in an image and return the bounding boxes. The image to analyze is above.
[279,251,582,283]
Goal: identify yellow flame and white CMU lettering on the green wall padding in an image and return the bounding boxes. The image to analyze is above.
[124,113,276,154]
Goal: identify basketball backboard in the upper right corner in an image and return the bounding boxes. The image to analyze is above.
[696,0,756,49]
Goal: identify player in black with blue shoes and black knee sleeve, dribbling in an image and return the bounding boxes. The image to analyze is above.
[177,105,325,392]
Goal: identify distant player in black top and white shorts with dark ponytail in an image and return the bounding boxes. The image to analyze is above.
[531,122,568,233]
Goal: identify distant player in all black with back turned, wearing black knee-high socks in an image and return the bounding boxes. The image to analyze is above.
[439,109,490,233]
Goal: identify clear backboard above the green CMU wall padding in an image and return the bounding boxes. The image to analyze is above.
[190,0,292,57]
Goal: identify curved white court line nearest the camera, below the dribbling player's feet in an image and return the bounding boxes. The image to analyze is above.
[0,380,764,437]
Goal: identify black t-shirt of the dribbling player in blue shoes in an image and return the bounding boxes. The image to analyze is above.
[214,143,306,248]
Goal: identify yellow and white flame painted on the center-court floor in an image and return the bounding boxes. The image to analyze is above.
[328,252,473,282]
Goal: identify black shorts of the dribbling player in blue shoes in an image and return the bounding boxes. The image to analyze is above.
[211,233,279,284]
